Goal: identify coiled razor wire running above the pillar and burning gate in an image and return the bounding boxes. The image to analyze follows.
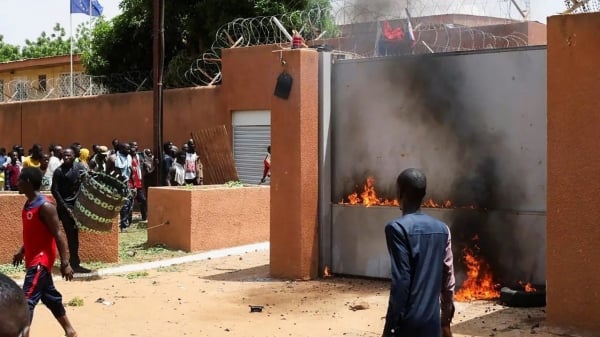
[185,0,532,86]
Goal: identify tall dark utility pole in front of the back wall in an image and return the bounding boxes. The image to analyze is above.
[152,0,165,186]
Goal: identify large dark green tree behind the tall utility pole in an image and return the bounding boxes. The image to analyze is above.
[83,0,329,87]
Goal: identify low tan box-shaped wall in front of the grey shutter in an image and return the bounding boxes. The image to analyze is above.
[148,185,270,252]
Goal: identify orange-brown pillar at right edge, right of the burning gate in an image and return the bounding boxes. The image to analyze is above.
[546,13,600,335]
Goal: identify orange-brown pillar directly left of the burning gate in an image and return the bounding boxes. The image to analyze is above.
[270,49,319,279]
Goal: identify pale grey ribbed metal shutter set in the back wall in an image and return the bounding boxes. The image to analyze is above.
[232,111,271,184]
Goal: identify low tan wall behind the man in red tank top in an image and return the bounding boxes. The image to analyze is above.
[0,192,119,263]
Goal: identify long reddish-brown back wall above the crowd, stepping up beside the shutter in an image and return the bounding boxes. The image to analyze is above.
[0,46,280,151]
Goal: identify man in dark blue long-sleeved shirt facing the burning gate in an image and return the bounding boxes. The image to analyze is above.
[382,168,455,337]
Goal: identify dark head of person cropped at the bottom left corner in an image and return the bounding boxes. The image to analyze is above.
[0,274,29,337]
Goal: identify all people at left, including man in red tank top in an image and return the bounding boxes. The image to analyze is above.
[0,139,271,337]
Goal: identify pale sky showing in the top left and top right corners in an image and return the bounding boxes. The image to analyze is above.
[0,0,565,46]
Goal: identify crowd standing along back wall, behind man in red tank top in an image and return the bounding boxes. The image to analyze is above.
[0,139,203,273]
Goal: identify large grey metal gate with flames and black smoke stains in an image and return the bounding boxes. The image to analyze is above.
[320,47,546,300]
